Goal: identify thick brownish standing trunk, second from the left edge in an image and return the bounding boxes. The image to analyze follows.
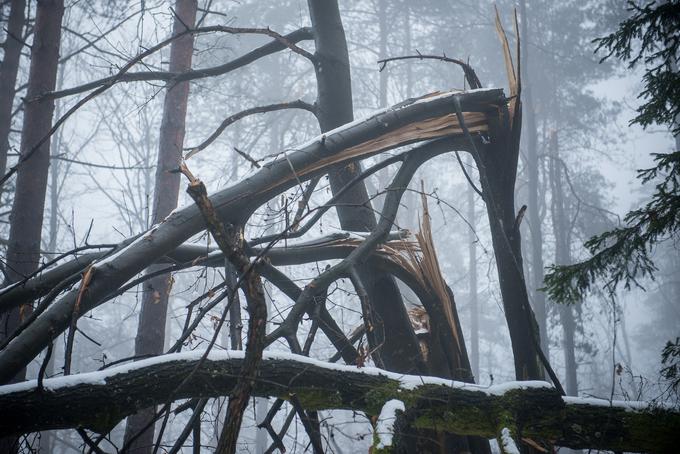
[0,0,64,452]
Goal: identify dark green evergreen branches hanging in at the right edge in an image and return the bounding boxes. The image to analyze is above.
[545,0,680,303]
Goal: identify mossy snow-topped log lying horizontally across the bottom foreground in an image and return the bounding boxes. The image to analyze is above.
[0,351,680,452]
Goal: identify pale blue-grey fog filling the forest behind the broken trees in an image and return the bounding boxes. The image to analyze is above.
[0,0,680,453]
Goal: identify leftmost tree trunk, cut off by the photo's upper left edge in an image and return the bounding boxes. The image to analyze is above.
[0,0,26,181]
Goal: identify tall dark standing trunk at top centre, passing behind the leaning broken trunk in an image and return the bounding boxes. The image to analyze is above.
[308,0,424,373]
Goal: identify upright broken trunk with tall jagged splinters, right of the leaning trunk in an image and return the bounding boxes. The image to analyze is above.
[472,12,548,382]
